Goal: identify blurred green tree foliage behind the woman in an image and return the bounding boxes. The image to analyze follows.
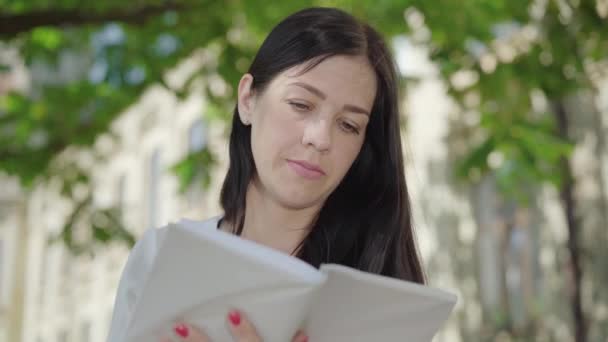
[0,0,608,340]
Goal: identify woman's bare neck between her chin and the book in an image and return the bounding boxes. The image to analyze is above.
[228,181,319,254]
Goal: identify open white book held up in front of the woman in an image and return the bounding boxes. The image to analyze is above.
[127,220,456,342]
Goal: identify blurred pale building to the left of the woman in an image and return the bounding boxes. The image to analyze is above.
[0,49,227,342]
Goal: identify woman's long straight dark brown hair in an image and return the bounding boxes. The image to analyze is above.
[220,8,424,283]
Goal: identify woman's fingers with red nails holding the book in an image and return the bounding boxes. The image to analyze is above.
[161,310,308,342]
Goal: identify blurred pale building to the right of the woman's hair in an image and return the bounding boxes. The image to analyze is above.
[397,36,608,341]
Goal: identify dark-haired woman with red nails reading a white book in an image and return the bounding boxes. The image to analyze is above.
[109,8,424,342]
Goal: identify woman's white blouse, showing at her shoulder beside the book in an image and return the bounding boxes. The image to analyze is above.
[108,216,220,342]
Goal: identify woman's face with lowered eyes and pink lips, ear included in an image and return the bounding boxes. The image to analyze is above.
[239,56,376,209]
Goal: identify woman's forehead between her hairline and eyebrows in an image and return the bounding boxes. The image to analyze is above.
[275,55,377,110]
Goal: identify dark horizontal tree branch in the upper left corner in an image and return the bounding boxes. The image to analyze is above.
[0,2,185,39]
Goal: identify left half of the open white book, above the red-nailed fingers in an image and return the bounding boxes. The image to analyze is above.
[127,222,326,342]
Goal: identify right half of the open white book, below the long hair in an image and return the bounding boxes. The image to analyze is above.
[305,264,456,342]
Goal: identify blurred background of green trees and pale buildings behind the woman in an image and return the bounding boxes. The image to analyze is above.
[0,0,608,342]
